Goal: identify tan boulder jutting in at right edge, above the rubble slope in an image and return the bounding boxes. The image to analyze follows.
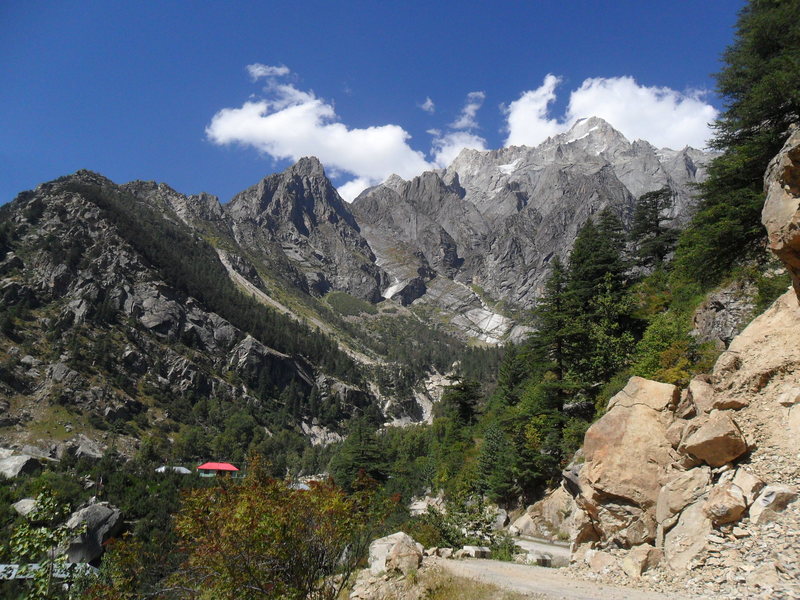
[761,128,800,297]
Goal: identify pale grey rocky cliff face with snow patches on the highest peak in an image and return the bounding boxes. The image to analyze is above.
[352,118,712,339]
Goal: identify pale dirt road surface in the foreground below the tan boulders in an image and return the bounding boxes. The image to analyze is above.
[435,559,682,600]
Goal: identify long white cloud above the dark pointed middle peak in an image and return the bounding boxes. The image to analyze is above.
[206,70,433,202]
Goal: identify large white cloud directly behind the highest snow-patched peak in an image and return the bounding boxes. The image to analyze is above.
[505,75,717,149]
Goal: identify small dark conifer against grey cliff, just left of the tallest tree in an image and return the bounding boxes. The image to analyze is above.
[629,188,678,267]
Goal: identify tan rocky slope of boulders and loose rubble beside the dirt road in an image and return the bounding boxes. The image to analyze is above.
[515,130,800,598]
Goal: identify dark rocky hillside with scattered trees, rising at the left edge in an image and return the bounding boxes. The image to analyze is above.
[0,171,377,462]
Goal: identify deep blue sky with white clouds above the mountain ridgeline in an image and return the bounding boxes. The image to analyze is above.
[0,0,743,202]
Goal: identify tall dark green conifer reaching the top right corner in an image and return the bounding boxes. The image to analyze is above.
[676,0,800,285]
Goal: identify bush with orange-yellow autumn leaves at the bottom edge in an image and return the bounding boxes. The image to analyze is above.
[171,467,389,600]
